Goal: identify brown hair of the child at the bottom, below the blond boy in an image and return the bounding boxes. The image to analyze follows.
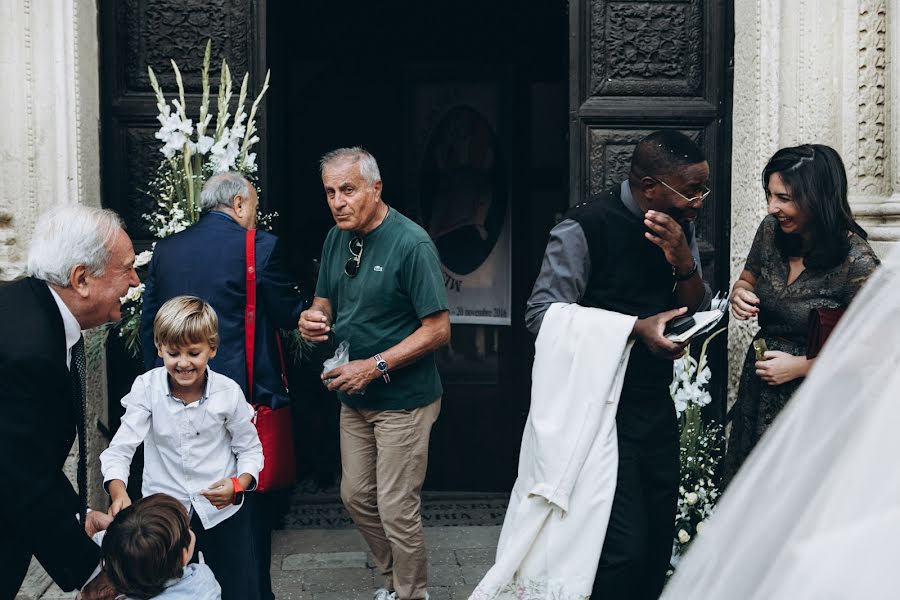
[103,494,191,600]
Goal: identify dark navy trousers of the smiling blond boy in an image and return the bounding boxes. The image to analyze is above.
[191,502,259,600]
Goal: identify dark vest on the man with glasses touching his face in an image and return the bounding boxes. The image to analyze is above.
[565,185,675,388]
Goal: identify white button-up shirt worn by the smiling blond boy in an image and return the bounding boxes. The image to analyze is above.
[100,367,263,529]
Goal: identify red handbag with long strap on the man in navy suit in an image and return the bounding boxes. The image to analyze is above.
[244,229,297,492]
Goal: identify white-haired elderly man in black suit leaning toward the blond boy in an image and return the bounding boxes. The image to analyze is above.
[0,205,139,600]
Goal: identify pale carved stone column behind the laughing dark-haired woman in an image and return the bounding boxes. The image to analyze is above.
[729,0,900,401]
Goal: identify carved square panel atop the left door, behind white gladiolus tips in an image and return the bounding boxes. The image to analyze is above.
[116,0,253,94]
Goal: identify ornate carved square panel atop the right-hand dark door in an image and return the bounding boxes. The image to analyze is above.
[589,0,704,96]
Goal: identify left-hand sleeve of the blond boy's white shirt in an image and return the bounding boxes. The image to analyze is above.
[100,378,152,488]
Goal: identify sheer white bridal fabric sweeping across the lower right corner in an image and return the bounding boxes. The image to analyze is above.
[662,250,900,600]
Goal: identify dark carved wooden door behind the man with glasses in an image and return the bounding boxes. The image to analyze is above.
[569,0,734,418]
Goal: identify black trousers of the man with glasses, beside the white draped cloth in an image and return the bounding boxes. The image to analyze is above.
[591,383,680,600]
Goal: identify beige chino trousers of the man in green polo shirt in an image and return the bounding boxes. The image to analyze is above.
[341,398,441,600]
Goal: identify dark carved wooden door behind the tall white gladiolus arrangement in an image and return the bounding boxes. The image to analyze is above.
[98,0,267,429]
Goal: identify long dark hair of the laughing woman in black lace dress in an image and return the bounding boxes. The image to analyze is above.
[762,144,867,269]
